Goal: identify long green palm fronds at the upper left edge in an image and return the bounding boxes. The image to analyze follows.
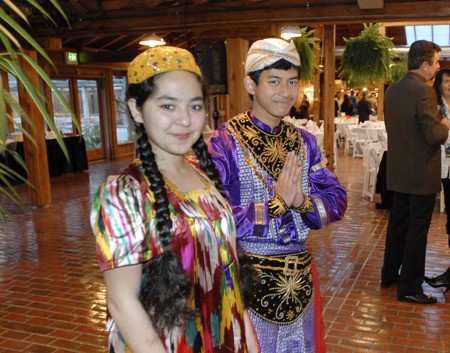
[0,0,79,220]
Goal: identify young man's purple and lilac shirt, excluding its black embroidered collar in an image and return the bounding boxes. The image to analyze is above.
[209,114,347,255]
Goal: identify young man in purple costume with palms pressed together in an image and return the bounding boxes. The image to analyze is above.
[209,38,347,353]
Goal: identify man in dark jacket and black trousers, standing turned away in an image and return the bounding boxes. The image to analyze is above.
[381,40,450,304]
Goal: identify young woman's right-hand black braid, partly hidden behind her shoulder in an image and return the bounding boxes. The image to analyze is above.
[192,136,259,307]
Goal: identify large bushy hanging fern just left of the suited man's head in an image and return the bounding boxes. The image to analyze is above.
[339,23,394,87]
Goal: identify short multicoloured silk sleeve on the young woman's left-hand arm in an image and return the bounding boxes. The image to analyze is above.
[90,175,154,271]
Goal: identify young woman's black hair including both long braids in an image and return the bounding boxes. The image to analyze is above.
[127,75,253,332]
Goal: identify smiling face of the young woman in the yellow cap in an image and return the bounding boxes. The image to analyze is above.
[129,71,205,158]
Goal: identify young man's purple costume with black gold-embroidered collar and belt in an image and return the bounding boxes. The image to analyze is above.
[209,113,347,353]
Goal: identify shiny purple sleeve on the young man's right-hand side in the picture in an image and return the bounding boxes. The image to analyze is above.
[301,133,347,229]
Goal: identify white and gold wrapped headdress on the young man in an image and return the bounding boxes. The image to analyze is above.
[245,38,300,75]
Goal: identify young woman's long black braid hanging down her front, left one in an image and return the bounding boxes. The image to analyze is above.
[136,124,195,332]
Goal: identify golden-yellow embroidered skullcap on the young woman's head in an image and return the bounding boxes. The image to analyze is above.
[128,46,202,83]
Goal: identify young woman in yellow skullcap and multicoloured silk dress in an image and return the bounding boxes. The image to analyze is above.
[91,47,259,353]
